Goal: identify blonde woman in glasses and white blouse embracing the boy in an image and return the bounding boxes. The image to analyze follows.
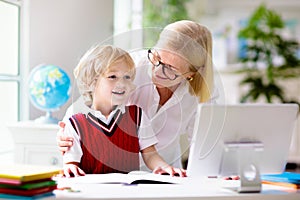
[58,20,216,170]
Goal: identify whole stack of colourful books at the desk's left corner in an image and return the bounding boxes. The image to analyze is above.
[0,165,61,198]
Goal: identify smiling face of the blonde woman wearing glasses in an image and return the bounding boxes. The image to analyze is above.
[152,50,193,87]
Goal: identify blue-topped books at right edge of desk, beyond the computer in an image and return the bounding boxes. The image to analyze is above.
[261,172,300,190]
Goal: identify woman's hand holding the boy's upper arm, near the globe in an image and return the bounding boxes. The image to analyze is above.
[56,121,73,155]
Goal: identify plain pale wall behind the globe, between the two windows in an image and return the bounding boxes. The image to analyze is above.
[24,0,113,119]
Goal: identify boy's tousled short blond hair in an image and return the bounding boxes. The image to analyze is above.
[74,45,135,106]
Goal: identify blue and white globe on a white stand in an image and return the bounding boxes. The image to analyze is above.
[28,65,71,123]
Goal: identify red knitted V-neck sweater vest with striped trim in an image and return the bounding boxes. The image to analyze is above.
[70,106,142,174]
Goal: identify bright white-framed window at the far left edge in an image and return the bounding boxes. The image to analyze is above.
[0,0,21,149]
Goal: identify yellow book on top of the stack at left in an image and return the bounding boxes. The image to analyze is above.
[0,165,61,182]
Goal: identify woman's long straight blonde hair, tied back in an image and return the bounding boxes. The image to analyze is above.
[155,20,213,102]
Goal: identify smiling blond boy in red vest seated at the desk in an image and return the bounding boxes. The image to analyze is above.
[64,45,186,177]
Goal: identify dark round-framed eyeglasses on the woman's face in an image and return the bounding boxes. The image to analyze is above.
[148,49,189,81]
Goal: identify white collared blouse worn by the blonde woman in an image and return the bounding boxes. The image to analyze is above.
[129,64,198,170]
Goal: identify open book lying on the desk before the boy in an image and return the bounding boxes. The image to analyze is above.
[57,172,186,184]
